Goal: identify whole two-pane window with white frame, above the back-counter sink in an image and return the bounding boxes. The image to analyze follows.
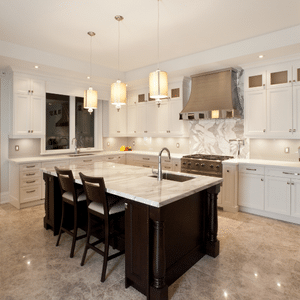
[41,93,98,154]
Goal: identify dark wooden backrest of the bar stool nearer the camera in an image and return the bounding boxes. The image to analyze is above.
[79,172,109,217]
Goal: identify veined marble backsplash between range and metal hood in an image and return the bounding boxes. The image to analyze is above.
[190,119,249,158]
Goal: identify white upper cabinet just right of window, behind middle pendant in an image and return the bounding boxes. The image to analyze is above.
[102,101,127,137]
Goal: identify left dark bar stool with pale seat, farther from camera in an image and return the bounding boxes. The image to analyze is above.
[55,167,87,257]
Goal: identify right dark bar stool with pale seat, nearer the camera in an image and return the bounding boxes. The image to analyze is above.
[79,173,126,282]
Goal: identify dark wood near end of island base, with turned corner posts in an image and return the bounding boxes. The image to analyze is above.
[125,185,220,300]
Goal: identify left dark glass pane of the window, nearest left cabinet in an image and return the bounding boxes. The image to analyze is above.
[46,93,70,150]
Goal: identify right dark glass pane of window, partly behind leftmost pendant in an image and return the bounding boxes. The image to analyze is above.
[75,97,94,148]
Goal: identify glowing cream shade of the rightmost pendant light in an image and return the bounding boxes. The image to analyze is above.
[149,70,168,99]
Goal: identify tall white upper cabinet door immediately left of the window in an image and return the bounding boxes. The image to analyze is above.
[30,96,45,135]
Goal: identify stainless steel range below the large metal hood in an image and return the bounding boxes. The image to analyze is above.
[181,154,233,177]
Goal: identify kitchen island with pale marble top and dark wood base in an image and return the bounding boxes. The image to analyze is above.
[43,162,222,299]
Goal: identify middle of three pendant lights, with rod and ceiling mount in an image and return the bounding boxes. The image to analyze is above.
[111,15,126,111]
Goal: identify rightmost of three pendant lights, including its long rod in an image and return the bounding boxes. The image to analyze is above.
[149,0,168,106]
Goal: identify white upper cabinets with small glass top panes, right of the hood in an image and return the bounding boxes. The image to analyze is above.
[245,61,300,139]
